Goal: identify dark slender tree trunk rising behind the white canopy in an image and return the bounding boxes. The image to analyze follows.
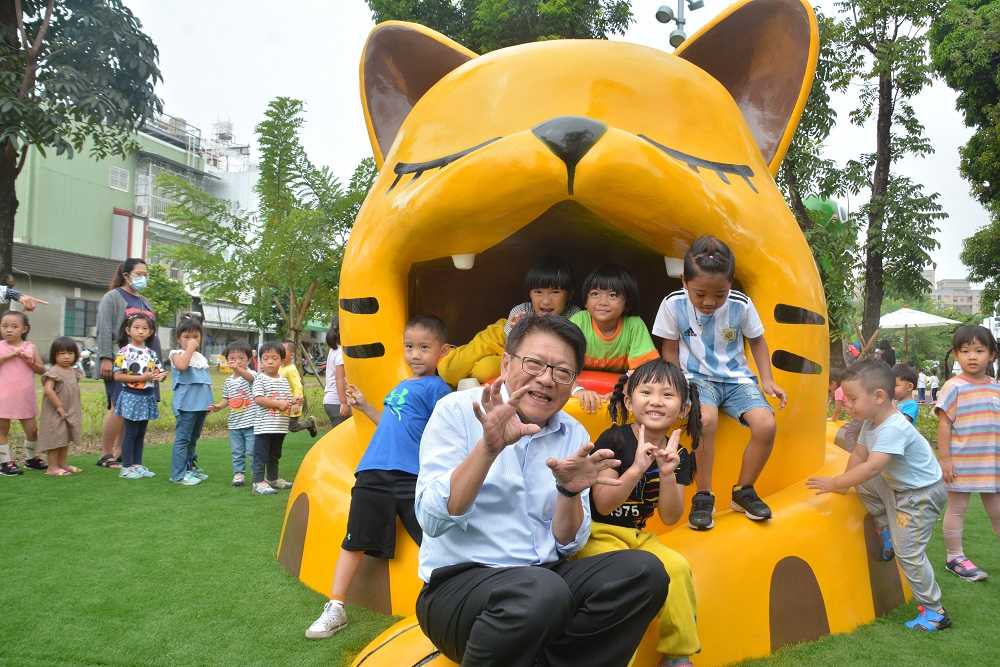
[861,73,893,339]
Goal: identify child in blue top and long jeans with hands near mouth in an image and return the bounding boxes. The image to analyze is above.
[170,315,212,486]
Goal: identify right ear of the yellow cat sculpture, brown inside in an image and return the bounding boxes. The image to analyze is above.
[675,0,819,175]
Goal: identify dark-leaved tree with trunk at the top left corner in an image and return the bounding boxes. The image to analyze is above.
[0,0,162,273]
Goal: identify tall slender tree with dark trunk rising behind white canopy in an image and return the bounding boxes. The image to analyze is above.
[837,0,946,337]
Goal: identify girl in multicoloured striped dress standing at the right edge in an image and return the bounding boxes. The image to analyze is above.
[934,326,1000,581]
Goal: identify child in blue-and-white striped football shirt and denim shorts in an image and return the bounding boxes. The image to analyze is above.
[653,236,786,530]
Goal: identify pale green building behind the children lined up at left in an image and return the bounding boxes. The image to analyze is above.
[13,116,266,360]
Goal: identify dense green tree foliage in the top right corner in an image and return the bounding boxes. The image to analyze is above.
[928,0,1000,211]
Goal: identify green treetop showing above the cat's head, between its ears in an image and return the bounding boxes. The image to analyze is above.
[368,0,633,53]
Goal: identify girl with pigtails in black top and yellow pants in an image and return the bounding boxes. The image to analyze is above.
[577,359,701,667]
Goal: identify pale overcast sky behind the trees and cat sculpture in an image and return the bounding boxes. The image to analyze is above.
[126,0,987,279]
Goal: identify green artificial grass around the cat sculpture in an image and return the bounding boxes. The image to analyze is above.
[0,433,1000,667]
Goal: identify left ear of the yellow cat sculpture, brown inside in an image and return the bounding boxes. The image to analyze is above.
[361,21,476,167]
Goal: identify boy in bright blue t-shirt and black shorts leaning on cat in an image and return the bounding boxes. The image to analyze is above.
[306,315,451,639]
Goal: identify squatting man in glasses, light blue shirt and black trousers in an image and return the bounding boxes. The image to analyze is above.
[415,315,667,667]
